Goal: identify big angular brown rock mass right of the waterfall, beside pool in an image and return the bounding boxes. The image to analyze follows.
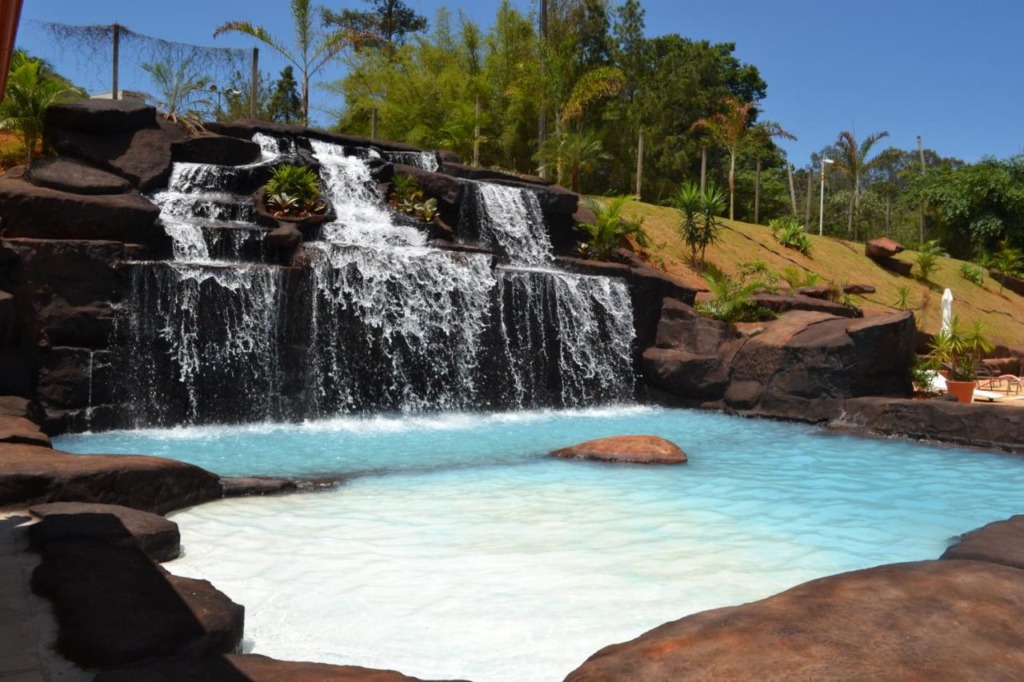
[642,303,913,422]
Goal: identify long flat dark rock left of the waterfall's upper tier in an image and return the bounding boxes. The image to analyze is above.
[0,176,160,245]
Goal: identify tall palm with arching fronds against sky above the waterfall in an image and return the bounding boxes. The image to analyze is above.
[213,0,358,125]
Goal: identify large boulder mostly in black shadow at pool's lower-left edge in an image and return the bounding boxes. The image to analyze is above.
[32,541,245,668]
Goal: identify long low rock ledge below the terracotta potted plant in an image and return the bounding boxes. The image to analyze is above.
[836,397,1024,453]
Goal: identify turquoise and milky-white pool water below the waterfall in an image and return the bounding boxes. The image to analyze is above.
[55,408,1024,682]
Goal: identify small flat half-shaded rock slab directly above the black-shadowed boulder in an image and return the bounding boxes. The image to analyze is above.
[29,502,181,561]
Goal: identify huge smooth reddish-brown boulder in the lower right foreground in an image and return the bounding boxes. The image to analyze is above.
[565,561,1024,682]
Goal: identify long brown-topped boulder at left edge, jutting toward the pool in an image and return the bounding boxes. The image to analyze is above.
[0,444,220,514]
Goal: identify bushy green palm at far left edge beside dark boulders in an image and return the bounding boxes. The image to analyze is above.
[0,50,82,164]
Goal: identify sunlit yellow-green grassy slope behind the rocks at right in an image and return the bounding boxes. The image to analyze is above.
[624,196,1024,346]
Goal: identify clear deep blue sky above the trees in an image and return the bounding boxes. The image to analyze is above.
[18,0,1024,167]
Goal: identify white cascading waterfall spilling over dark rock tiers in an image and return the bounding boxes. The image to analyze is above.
[116,129,633,426]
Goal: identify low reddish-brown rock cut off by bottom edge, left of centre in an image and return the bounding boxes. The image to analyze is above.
[95,654,468,682]
